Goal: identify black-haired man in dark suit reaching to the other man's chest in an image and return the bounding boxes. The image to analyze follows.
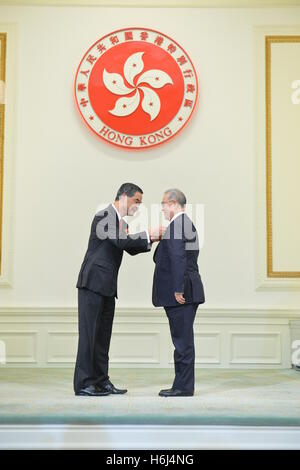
[74,183,162,396]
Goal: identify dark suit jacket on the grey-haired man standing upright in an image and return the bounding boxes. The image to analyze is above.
[152,213,205,307]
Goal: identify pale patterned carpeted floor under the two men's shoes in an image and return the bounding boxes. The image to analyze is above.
[0,367,300,426]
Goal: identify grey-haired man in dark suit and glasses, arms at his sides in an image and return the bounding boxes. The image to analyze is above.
[152,189,205,397]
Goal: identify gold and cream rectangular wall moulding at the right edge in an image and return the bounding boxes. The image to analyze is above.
[254,25,300,291]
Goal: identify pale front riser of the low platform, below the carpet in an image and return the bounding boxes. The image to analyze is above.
[0,425,300,450]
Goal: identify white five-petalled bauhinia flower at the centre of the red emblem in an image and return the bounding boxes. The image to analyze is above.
[103,52,173,121]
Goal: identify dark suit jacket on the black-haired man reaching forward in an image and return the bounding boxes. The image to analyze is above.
[76,204,151,297]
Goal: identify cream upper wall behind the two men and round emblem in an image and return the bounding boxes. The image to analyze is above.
[0,6,300,308]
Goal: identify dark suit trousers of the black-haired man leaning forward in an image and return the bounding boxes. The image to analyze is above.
[74,288,115,393]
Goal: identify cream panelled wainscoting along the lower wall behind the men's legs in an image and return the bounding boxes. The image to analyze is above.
[0,307,300,368]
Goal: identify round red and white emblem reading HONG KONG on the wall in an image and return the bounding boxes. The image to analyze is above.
[75,28,198,149]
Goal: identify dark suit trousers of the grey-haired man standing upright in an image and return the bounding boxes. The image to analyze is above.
[164,304,199,392]
